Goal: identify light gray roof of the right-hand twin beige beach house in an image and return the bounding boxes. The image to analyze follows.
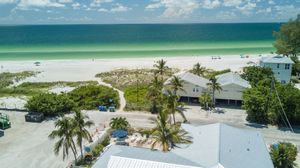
[216,72,251,88]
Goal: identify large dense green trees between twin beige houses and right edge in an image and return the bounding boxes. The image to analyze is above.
[243,79,300,127]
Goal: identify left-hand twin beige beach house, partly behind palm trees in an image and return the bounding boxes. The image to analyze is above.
[164,72,209,103]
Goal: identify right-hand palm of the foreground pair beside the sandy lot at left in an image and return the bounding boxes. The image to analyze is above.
[72,110,94,160]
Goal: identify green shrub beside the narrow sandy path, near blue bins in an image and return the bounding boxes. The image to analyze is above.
[68,85,119,110]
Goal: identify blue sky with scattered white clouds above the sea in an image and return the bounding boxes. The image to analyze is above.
[0,0,300,25]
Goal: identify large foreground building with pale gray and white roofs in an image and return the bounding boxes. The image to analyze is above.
[93,123,273,168]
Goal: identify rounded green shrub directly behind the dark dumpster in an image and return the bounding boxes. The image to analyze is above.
[25,93,76,116]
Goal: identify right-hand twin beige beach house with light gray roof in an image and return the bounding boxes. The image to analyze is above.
[215,72,251,105]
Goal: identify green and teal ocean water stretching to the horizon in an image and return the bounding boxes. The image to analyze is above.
[0,23,280,60]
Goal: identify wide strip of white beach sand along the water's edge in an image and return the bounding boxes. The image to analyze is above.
[0,55,260,82]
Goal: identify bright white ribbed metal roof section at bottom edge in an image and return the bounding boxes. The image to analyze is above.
[107,156,200,168]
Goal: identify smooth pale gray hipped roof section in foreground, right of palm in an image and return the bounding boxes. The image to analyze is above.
[172,123,273,168]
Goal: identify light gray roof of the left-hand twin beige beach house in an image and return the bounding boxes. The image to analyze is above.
[164,72,209,88]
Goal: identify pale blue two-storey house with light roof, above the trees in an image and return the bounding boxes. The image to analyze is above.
[259,55,294,84]
